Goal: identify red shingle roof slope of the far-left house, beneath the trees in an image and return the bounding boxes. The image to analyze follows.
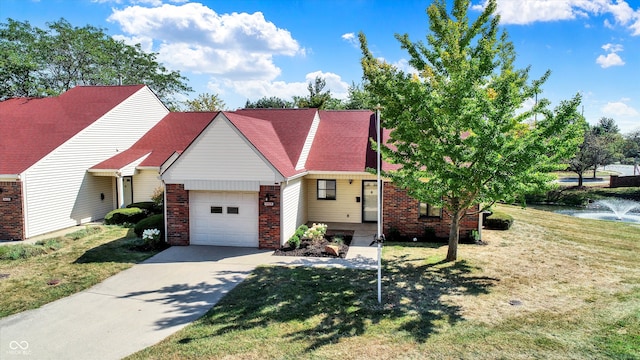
[0,85,144,174]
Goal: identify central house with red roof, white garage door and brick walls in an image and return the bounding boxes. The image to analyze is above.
[161,109,478,248]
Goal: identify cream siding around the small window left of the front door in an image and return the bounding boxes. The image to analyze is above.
[306,175,362,223]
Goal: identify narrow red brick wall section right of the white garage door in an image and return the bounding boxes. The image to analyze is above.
[258,185,281,249]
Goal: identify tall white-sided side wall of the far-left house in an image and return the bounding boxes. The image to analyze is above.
[24,87,168,237]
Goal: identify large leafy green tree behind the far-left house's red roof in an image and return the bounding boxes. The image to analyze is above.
[0,19,192,107]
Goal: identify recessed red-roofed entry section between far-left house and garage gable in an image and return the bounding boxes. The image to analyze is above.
[89,112,217,207]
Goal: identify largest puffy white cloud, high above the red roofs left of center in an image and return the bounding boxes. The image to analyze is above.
[108,0,305,80]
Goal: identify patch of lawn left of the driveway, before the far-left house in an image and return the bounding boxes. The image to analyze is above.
[0,226,162,317]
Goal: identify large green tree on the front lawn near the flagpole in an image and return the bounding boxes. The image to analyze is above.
[359,0,582,261]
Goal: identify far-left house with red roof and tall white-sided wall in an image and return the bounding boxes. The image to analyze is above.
[0,85,169,240]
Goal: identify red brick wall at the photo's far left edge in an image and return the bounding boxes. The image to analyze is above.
[0,181,24,240]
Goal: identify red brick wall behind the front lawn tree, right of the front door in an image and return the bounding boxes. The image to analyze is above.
[382,183,478,239]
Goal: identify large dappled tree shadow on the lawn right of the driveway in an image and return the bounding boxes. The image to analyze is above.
[179,256,498,351]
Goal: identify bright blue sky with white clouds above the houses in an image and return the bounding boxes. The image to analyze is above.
[0,0,640,132]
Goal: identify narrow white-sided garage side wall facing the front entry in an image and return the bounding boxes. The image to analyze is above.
[280,178,307,245]
